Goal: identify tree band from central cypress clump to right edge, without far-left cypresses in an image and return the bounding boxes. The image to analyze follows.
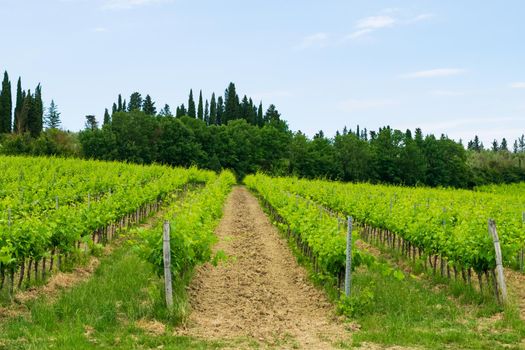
[79,83,525,188]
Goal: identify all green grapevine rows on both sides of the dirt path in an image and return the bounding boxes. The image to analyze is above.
[0,157,525,300]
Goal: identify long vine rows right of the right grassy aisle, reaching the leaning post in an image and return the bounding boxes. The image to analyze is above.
[249,174,525,273]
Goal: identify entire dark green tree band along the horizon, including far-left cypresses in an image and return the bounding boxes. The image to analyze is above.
[0,73,525,188]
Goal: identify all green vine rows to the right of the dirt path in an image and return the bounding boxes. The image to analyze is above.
[245,174,525,300]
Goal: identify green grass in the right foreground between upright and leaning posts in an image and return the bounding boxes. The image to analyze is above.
[353,260,525,349]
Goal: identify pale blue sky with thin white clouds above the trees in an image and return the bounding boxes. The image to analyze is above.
[0,0,525,144]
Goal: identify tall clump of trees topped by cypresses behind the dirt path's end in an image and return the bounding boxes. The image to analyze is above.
[79,83,291,177]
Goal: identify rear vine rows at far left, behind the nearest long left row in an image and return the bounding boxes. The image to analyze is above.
[0,156,170,216]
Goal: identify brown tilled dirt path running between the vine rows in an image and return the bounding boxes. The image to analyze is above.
[178,187,350,349]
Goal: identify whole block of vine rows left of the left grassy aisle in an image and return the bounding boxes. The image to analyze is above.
[0,157,214,294]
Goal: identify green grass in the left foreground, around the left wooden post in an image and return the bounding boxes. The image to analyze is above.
[0,241,224,350]
